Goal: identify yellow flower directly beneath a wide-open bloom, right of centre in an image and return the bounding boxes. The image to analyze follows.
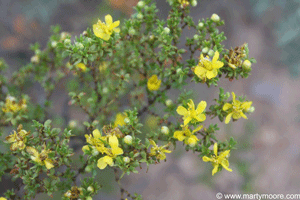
[173,126,203,147]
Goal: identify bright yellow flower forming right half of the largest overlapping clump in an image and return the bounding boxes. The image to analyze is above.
[97,135,124,169]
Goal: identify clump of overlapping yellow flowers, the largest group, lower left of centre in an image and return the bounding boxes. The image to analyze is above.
[82,129,124,169]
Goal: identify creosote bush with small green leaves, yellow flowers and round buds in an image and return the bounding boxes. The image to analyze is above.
[0,0,255,200]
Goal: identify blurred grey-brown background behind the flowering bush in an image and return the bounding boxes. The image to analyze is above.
[0,0,300,200]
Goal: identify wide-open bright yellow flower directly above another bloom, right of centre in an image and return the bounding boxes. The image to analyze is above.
[176,99,207,125]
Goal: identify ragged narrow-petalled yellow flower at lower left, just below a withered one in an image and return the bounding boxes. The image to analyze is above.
[26,144,54,169]
